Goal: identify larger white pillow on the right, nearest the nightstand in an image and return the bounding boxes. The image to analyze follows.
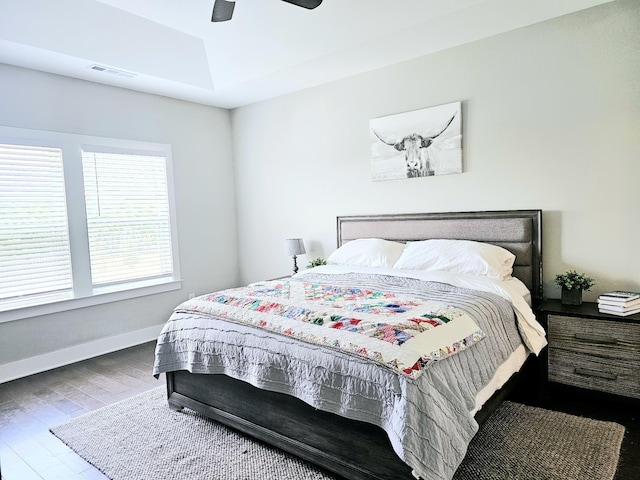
[393,239,516,280]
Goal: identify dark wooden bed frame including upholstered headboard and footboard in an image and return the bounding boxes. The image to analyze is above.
[166,210,542,480]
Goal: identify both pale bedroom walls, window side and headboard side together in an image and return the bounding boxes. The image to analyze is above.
[0,0,640,382]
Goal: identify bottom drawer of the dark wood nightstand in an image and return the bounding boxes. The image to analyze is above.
[549,348,640,399]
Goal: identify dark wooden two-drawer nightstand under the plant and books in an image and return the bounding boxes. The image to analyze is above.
[538,300,640,399]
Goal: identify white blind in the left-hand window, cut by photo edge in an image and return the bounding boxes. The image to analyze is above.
[0,144,72,305]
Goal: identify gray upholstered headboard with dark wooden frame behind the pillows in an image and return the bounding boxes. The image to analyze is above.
[337,210,542,301]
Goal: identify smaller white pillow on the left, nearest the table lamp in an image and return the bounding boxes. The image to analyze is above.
[327,238,404,268]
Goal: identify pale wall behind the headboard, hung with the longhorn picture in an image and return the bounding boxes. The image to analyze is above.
[232,0,640,300]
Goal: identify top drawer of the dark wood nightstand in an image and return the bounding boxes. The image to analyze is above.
[548,315,640,362]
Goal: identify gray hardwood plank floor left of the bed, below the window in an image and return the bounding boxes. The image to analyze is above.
[0,342,165,480]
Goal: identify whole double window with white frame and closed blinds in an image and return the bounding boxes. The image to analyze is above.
[0,127,180,321]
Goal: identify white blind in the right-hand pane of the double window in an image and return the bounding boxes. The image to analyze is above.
[82,147,174,286]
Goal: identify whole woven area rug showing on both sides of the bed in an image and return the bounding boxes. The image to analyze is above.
[51,387,624,480]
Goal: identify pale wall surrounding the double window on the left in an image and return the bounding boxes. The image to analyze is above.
[0,64,238,372]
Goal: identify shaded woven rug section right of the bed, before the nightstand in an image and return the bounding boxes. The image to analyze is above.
[454,402,624,480]
